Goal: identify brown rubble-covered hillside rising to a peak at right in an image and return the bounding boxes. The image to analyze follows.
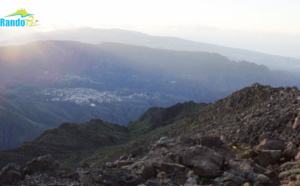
[191,84,300,145]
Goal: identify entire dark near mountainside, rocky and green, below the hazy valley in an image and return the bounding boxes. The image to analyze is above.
[0,84,300,185]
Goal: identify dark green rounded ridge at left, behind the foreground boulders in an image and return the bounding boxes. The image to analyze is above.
[1,120,129,169]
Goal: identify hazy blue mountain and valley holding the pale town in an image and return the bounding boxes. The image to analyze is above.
[0,41,277,150]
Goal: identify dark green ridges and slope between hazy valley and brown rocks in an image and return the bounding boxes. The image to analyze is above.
[0,102,206,169]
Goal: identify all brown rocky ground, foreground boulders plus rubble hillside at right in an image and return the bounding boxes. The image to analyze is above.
[0,84,300,186]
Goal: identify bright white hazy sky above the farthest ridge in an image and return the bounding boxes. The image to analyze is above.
[0,0,300,58]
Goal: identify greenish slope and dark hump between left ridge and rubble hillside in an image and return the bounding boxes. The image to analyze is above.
[66,102,206,164]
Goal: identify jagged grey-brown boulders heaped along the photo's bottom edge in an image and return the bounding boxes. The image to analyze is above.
[0,136,300,186]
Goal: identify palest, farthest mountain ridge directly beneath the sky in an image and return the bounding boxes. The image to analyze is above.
[0,28,300,72]
